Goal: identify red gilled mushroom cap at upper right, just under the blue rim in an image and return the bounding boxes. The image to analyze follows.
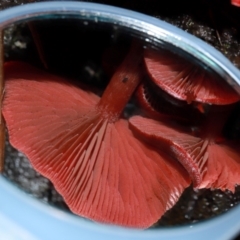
[144,49,240,105]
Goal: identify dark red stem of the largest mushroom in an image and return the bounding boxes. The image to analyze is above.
[97,42,142,122]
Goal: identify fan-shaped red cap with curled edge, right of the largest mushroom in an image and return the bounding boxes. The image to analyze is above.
[129,116,240,191]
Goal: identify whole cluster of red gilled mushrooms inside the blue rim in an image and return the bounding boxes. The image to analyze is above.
[2,40,240,228]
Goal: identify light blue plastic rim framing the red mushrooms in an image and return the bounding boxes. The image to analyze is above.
[0,1,240,240]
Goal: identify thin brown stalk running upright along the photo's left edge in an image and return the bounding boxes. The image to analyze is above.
[0,30,5,172]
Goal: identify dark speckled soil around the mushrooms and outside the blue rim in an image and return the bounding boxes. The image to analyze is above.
[0,0,240,227]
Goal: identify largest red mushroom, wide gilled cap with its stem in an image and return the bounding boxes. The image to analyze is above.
[3,43,190,228]
